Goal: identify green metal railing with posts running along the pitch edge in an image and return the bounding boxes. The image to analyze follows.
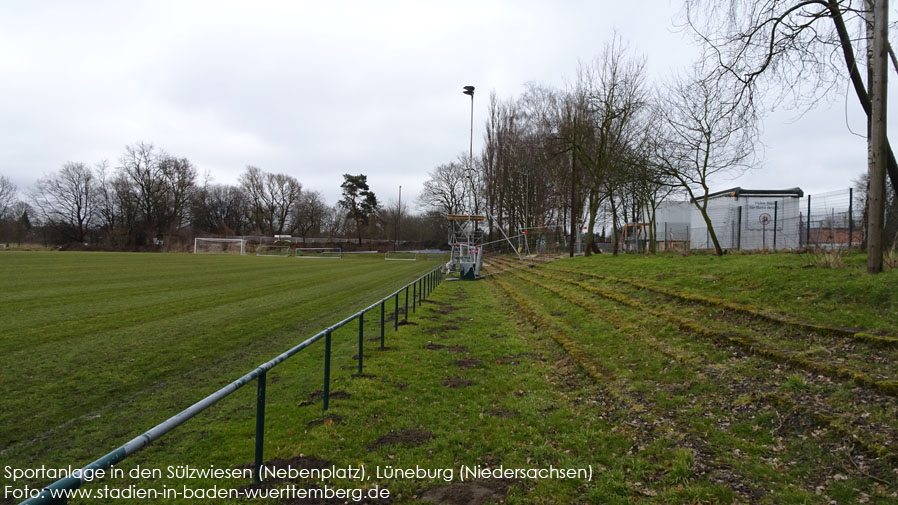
[19,267,444,505]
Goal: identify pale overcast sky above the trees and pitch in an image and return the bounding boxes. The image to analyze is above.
[0,0,884,209]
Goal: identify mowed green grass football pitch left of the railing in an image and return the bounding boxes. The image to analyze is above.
[0,252,438,472]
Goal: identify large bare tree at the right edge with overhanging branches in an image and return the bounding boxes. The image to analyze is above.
[685,0,898,273]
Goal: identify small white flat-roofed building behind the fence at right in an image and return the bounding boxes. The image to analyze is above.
[688,188,804,250]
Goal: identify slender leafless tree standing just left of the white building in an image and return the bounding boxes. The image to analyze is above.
[654,70,757,255]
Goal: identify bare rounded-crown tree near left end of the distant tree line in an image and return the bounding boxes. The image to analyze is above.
[32,162,97,242]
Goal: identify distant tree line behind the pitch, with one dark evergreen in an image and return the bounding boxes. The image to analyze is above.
[0,142,445,250]
